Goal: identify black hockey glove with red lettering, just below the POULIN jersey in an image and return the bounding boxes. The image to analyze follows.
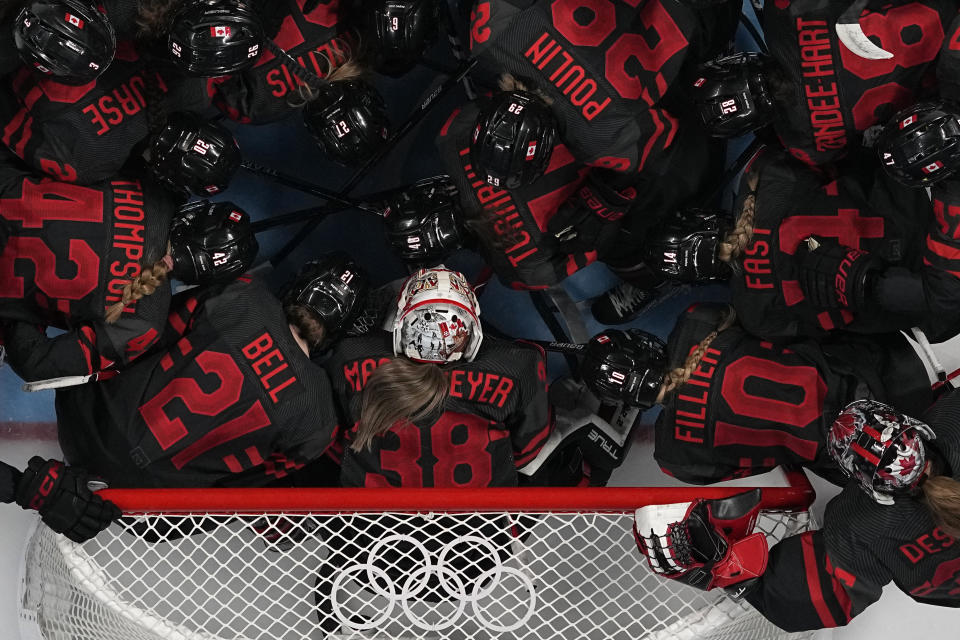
[547,174,636,253]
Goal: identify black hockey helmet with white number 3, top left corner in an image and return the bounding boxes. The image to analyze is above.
[13,0,117,85]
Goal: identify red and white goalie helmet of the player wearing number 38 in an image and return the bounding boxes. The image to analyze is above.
[393,267,483,364]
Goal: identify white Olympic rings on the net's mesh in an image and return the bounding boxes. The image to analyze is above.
[330,534,537,633]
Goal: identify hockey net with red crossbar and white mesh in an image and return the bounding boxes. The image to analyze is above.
[20,474,813,640]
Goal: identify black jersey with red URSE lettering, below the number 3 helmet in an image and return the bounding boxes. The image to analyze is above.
[0,0,210,184]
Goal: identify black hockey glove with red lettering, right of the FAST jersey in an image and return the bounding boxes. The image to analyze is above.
[795,236,883,311]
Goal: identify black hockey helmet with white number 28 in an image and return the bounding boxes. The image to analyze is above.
[692,52,774,138]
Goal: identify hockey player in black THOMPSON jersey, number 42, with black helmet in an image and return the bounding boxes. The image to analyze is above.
[0,158,257,381]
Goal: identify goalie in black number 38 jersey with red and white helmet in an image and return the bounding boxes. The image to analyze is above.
[326,268,553,487]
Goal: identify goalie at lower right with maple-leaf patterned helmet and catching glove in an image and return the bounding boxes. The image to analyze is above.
[634,391,960,631]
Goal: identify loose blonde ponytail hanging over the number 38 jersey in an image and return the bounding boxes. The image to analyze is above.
[350,358,450,451]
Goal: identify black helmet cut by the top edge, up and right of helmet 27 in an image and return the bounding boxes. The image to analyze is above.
[357,0,440,76]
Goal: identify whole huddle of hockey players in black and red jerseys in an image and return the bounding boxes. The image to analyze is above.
[0,0,960,630]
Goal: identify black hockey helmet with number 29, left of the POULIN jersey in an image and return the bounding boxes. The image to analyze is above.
[470,91,557,189]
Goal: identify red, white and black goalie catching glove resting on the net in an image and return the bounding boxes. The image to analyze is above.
[633,489,768,595]
